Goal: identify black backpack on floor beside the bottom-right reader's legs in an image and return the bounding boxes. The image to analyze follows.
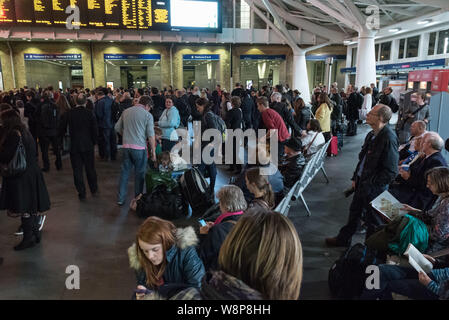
[328,243,381,300]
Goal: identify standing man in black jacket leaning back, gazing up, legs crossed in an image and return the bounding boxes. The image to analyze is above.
[326,105,399,246]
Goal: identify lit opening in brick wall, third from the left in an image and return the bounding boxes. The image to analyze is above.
[182,59,220,91]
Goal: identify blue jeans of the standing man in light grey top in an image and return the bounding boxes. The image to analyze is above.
[118,148,148,203]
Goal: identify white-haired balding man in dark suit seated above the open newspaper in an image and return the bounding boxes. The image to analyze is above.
[389,132,447,211]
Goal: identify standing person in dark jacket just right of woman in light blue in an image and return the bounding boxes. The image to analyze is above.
[194,98,219,195]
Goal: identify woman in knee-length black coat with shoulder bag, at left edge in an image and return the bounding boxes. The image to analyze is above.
[0,110,50,250]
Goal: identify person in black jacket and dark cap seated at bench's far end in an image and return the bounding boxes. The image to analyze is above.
[279,137,306,194]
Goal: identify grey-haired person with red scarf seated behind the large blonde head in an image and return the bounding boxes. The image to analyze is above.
[198,185,247,271]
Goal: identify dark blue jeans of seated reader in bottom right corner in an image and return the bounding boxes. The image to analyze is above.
[360,264,438,300]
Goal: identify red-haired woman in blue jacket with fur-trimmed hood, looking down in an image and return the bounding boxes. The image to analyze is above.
[128,217,204,299]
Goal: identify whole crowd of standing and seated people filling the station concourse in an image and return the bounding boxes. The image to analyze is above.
[0,83,449,299]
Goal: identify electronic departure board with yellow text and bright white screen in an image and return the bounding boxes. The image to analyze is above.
[0,0,221,32]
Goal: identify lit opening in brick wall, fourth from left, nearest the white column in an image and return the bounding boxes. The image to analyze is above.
[240,59,287,90]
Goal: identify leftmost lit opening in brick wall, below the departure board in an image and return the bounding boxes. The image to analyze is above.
[25,59,84,90]
